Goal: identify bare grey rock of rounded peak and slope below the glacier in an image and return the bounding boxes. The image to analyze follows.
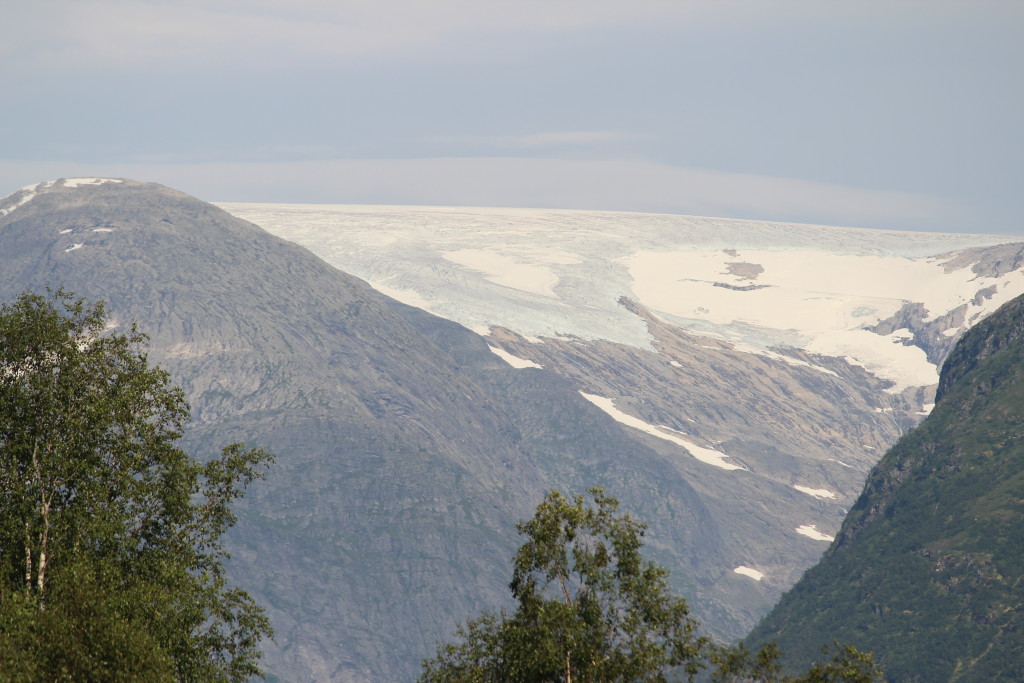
[0,179,1020,681]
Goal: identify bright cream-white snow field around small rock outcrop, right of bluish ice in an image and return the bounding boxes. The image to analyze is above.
[628,249,1024,392]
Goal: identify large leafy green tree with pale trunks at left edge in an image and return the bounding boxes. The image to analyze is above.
[0,290,272,681]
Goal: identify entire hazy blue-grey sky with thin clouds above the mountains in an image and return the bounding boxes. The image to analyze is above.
[0,0,1024,234]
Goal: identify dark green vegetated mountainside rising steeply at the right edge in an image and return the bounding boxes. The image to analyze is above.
[749,298,1024,681]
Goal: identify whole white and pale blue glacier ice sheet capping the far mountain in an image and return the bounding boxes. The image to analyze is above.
[221,204,1024,392]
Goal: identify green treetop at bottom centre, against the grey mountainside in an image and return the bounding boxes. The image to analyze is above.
[421,488,710,683]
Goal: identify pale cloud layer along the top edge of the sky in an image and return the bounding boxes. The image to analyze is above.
[0,0,795,68]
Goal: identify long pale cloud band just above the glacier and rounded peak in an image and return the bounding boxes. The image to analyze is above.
[0,158,966,231]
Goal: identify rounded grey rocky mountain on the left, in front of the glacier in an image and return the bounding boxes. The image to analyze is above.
[0,178,726,681]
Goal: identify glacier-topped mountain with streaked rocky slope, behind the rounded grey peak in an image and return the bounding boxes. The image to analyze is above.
[222,204,1024,638]
